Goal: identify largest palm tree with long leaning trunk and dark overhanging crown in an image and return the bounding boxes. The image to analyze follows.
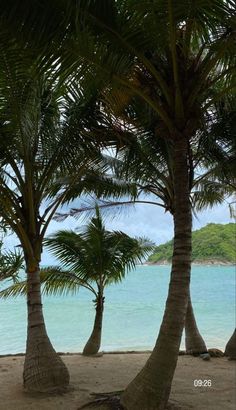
[57,0,235,410]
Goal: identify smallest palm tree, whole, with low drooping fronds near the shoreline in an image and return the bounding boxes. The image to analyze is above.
[1,207,154,355]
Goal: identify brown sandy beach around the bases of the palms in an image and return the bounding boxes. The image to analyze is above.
[0,353,236,410]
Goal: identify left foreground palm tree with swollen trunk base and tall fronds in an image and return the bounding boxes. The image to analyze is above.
[0,36,122,391]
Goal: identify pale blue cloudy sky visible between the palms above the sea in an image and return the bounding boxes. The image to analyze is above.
[4,199,233,265]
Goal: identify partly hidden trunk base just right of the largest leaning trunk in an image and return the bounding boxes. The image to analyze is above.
[185,292,207,356]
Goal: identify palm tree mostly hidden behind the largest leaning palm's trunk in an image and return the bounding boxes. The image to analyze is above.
[61,98,236,355]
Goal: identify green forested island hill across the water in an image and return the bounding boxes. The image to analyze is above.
[147,223,236,265]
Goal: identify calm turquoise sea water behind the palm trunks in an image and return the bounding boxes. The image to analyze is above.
[0,266,235,354]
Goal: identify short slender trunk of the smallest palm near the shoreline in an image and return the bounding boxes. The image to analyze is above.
[83,292,105,356]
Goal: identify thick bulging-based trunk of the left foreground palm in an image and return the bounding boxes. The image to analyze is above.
[23,266,69,392]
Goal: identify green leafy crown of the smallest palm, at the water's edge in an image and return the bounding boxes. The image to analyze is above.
[45,206,154,292]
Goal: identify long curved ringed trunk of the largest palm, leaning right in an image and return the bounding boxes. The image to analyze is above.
[121,138,192,410]
